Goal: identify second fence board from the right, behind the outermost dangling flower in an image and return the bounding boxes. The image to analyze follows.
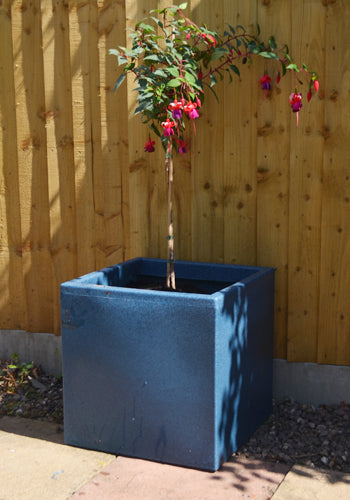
[287,0,325,362]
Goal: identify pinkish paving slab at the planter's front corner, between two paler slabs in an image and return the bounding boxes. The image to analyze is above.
[71,457,289,500]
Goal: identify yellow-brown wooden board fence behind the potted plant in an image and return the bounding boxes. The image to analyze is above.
[0,0,350,365]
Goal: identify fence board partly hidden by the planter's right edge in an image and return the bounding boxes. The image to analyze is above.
[257,0,292,358]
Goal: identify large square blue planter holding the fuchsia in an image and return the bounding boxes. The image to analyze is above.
[61,259,274,470]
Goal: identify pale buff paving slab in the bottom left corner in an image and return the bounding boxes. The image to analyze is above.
[0,417,115,500]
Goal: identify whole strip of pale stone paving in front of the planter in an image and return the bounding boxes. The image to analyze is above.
[0,417,350,500]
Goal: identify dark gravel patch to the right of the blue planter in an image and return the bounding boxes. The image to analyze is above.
[238,400,350,472]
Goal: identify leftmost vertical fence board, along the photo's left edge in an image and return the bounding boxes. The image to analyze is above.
[0,0,26,328]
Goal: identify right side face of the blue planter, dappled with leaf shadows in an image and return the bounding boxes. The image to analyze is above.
[218,272,274,466]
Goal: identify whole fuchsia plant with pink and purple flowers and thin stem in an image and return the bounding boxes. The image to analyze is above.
[110,3,319,289]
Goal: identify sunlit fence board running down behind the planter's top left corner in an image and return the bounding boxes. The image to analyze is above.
[41,0,77,333]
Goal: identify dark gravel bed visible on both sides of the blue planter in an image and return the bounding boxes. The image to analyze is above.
[0,360,350,472]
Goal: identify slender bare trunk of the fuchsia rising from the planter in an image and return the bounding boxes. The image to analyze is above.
[165,138,176,290]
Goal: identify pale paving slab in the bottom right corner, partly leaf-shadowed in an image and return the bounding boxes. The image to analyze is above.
[272,465,350,500]
